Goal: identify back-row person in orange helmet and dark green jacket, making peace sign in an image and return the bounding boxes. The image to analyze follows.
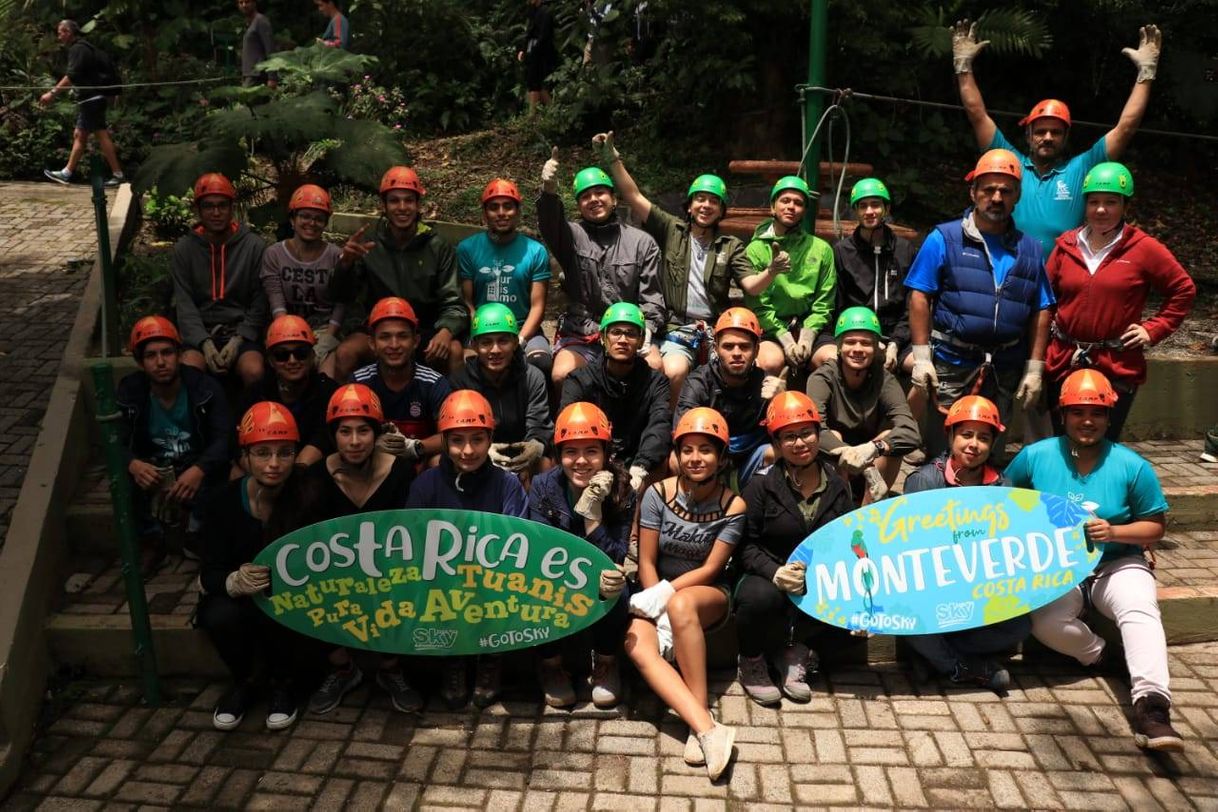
[326,167,469,380]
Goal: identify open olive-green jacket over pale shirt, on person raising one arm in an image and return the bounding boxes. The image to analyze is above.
[643,203,753,326]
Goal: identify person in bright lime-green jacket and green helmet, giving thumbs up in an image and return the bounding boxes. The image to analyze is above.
[744,175,837,375]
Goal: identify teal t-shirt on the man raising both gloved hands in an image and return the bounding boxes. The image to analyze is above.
[988,129,1108,257]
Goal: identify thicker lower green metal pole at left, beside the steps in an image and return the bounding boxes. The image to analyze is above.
[93,362,161,707]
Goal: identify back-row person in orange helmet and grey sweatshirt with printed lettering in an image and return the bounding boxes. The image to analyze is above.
[259,184,346,367]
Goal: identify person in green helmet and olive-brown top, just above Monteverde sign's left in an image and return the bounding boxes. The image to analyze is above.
[808,306,922,504]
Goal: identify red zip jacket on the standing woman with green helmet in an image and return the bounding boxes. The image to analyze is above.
[1045,224,1197,386]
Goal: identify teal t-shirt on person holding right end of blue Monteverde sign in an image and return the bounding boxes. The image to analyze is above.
[1004,437,1167,564]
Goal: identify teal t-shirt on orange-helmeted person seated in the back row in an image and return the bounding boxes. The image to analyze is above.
[457,231,551,325]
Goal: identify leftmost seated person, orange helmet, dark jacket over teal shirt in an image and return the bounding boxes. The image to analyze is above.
[116,315,233,576]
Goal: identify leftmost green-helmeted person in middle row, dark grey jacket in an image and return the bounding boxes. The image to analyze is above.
[448,302,554,487]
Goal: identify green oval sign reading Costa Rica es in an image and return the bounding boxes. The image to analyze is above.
[255,510,614,656]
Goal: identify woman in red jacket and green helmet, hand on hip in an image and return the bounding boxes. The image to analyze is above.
[1045,162,1197,441]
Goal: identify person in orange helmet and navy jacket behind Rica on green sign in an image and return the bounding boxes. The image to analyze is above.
[406,390,529,710]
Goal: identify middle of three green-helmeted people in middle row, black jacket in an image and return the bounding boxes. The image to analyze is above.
[558,302,672,493]
